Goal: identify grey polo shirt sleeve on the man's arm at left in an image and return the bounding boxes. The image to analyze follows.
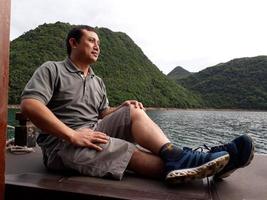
[21,62,57,105]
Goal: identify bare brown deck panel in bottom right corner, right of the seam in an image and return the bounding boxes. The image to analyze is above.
[211,154,267,200]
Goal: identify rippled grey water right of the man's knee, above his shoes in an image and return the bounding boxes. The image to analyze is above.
[147,109,267,153]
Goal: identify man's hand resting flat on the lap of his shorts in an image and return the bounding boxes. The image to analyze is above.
[71,128,109,151]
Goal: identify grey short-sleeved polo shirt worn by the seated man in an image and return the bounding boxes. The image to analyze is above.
[21,58,108,129]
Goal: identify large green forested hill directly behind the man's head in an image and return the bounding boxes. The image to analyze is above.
[9,22,200,108]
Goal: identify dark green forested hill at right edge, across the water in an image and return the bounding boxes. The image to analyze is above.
[178,56,267,110]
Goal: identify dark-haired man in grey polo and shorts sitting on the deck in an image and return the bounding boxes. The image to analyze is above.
[21,26,253,183]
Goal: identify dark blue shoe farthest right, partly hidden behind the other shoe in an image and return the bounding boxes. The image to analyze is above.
[208,135,254,179]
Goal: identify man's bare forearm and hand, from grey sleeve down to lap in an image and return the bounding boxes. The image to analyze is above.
[20,99,109,151]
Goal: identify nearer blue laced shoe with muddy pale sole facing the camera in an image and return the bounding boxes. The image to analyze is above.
[165,147,229,183]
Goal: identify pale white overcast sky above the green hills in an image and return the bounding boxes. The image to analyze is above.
[10,0,267,74]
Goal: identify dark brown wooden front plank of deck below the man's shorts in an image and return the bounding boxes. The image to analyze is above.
[6,173,209,200]
